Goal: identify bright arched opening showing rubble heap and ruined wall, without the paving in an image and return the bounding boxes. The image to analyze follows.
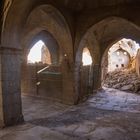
[102,38,140,94]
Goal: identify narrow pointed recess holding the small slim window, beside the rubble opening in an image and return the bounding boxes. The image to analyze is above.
[75,24,100,103]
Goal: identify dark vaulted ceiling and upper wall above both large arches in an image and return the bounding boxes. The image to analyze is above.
[3,0,140,47]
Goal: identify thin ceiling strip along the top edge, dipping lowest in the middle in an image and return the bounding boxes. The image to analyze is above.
[4,0,140,11]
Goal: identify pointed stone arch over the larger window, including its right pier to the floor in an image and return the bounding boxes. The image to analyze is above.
[21,5,74,104]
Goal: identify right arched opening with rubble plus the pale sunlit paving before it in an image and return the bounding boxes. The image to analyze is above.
[89,38,140,112]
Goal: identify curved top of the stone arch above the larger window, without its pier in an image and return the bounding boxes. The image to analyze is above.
[22,5,73,61]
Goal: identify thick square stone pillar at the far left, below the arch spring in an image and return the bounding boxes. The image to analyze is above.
[0,46,23,127]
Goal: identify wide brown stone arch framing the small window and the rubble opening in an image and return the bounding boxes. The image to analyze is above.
[75,16,140,102]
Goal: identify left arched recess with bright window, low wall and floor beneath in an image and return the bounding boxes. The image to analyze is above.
[21,37,64,121]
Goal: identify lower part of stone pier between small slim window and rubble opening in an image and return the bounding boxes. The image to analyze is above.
[93,64,101,90]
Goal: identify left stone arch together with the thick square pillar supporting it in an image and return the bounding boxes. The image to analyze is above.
[0,0,73,125]
